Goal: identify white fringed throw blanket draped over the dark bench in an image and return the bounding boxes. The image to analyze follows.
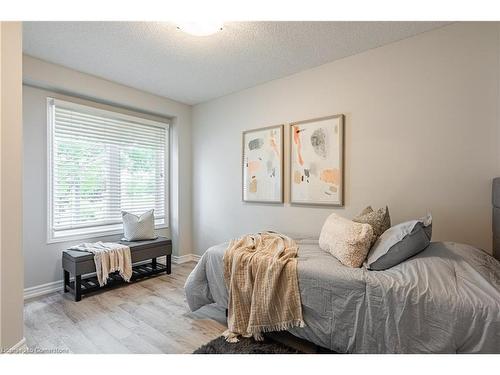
[70,241,132,286]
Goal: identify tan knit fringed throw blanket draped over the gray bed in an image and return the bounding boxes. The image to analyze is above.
[223,232,304,342]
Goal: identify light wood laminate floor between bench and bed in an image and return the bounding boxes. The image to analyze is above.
[24,262,226,353]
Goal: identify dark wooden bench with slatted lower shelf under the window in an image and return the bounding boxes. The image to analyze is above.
[62,237,172,301]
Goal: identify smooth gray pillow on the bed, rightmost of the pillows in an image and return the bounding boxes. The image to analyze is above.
[365,215,432,271]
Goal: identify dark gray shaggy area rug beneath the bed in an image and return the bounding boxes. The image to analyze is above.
[193,336,304,354]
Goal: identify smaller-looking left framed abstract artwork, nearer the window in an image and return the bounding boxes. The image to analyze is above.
[243,125,283,203]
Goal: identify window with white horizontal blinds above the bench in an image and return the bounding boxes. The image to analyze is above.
[48,98,169,242]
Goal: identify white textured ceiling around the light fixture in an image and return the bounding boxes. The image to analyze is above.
[23,22,446,104]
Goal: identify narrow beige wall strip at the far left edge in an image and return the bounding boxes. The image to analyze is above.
[0,22,23,353]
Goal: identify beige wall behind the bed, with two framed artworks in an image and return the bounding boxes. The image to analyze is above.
[192,23,500,254]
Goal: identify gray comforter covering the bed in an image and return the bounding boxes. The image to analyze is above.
[185,240,500,353]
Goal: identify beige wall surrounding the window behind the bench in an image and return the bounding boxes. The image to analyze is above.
[23,55,192,289]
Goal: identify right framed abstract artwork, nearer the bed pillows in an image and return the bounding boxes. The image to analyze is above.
[290,115,344,206]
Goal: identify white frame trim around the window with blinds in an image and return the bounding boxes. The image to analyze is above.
[46,97,171,244]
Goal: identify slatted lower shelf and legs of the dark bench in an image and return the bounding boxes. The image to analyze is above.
[64,259,170,301]
